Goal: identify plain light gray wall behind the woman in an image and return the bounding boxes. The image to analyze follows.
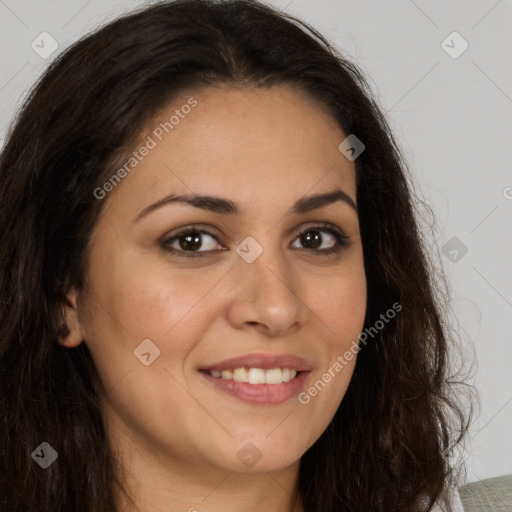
[0,0,512,488]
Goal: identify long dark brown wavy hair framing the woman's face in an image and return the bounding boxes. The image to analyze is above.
[0,0,471,512]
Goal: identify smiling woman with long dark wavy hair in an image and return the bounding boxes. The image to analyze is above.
[0,0,467,512]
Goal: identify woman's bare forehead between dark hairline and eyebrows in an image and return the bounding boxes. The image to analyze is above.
[100,85,355,218]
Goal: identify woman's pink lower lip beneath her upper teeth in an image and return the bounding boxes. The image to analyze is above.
[199,372,310,404]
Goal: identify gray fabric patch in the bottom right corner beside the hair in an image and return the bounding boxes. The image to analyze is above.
[459,475,512,512]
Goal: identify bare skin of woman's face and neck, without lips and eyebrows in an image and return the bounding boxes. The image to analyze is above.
[62,86,366,512]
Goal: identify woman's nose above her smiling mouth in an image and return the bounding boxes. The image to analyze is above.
[228,240,303,336]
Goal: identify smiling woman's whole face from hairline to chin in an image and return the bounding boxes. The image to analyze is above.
[65,86,366,472]
